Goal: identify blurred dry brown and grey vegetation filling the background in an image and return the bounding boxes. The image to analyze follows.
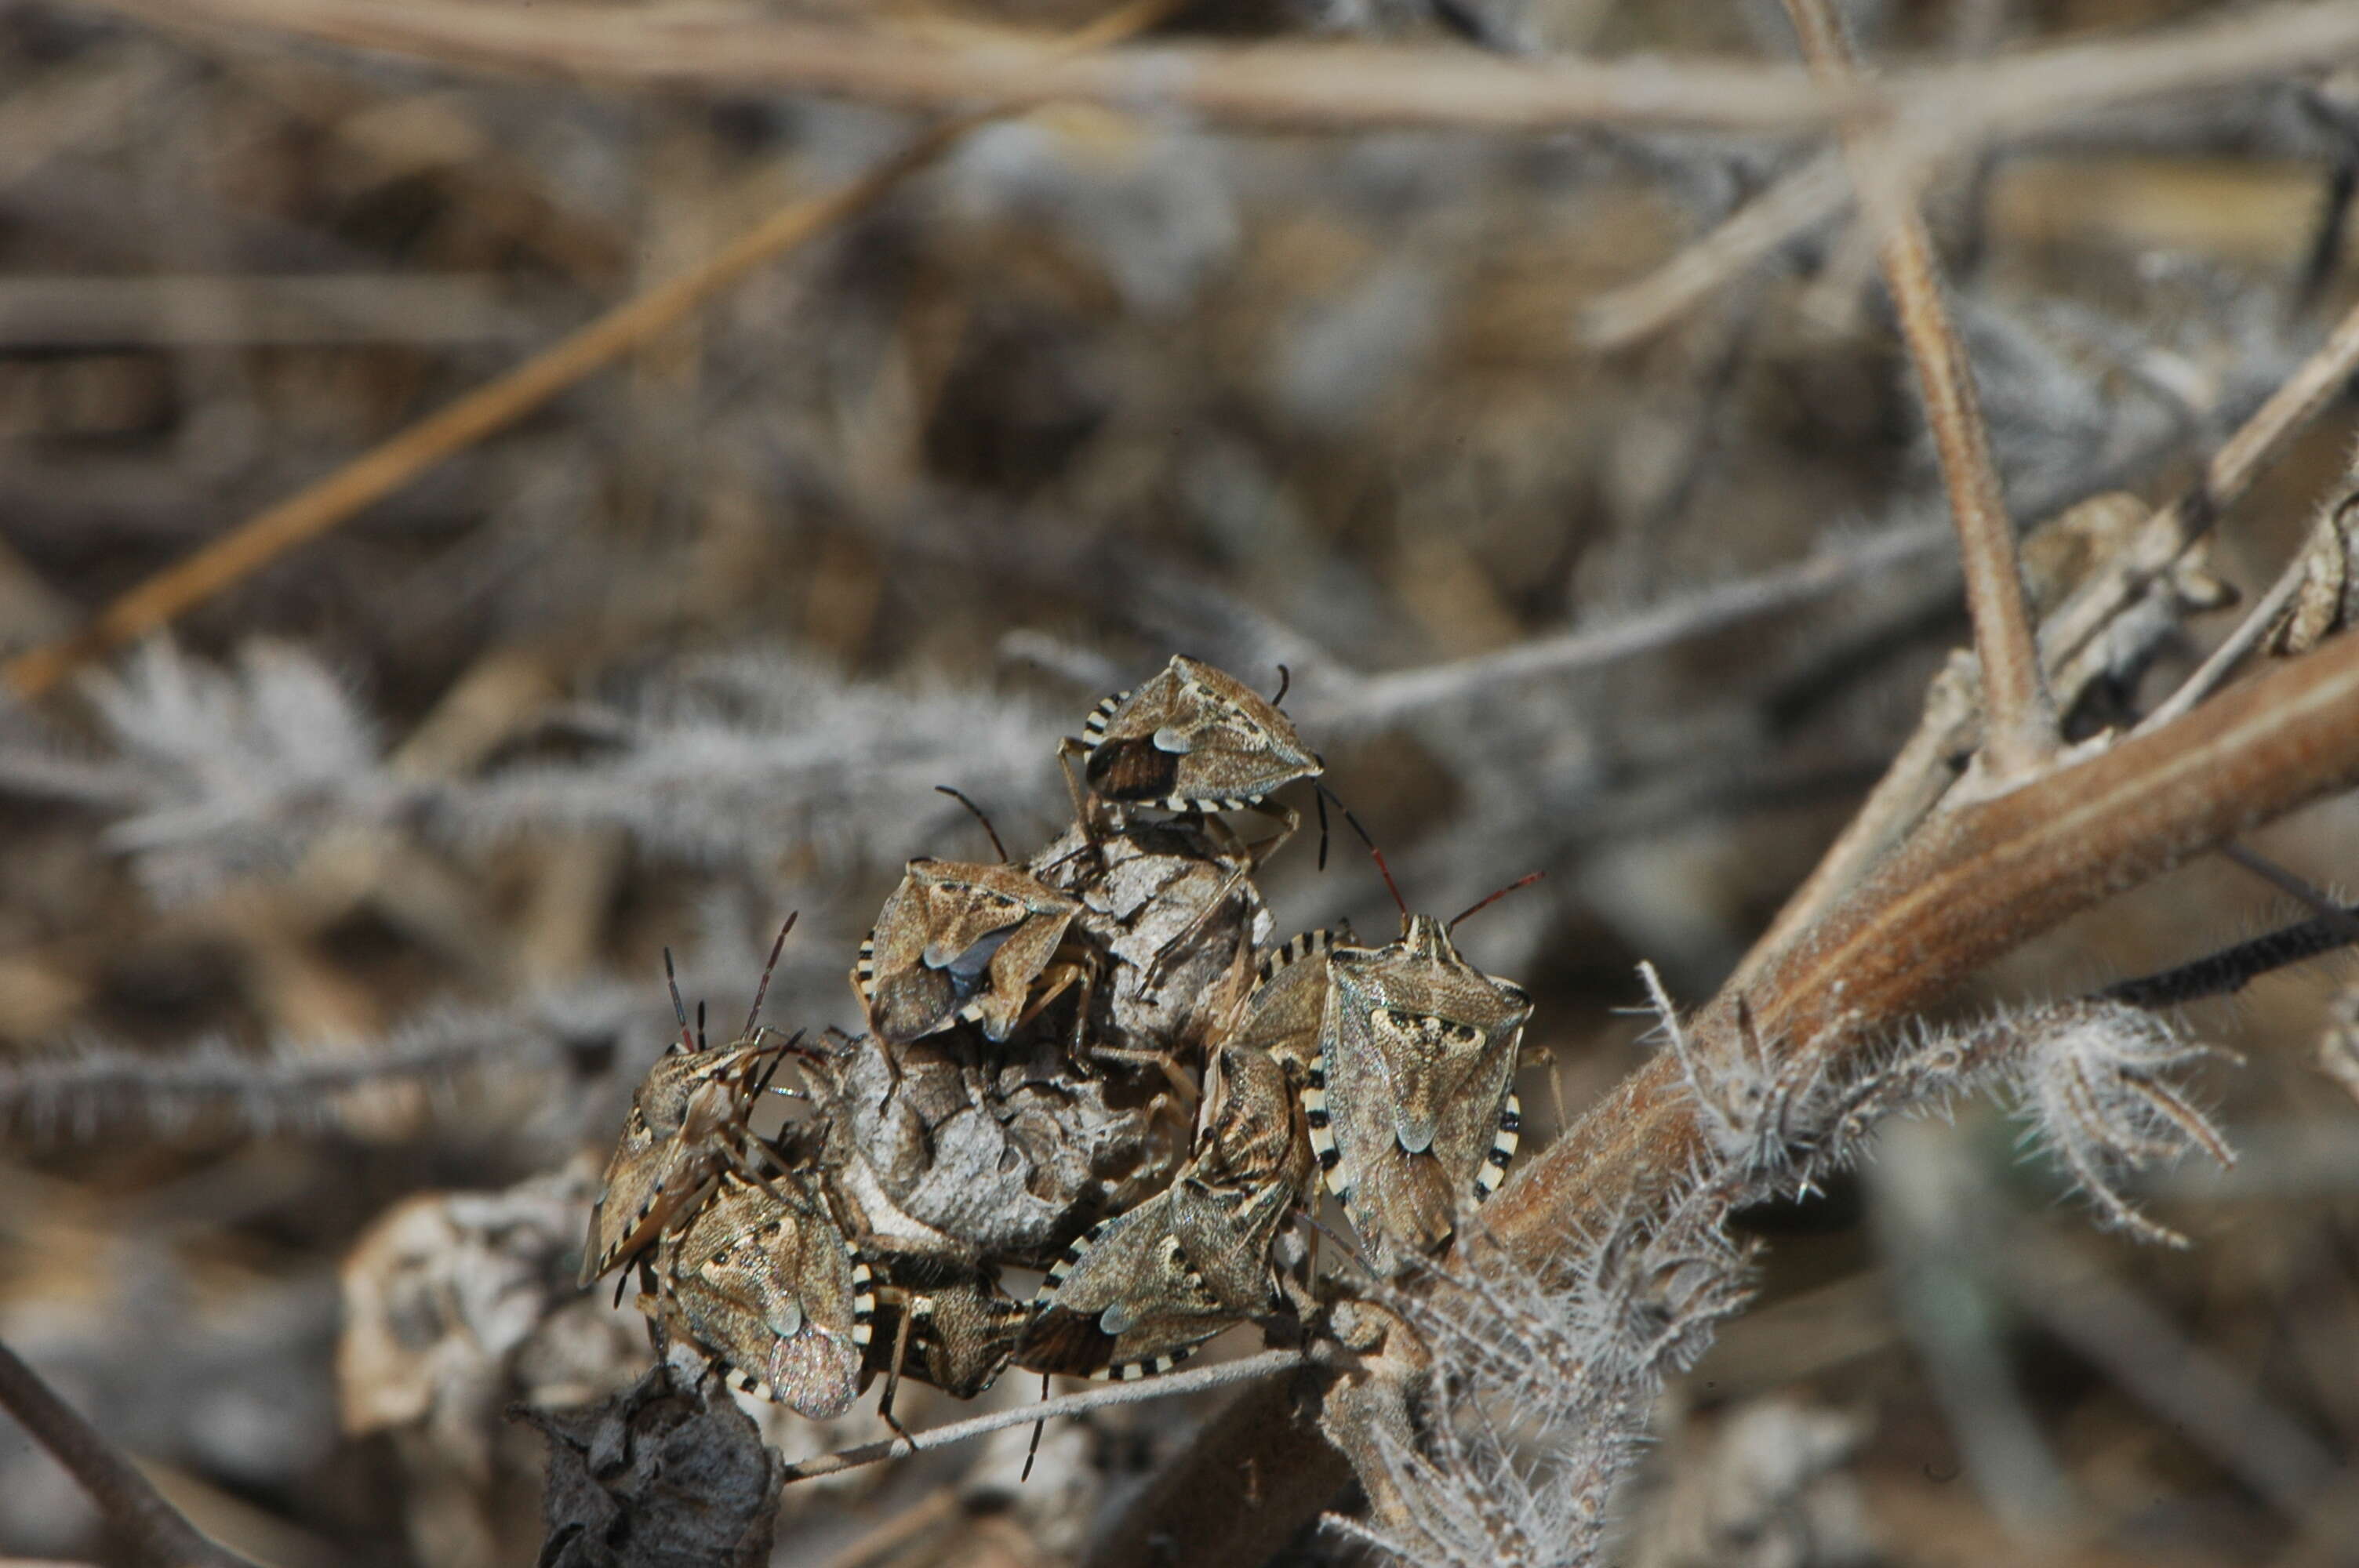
[0,0,2359,1568]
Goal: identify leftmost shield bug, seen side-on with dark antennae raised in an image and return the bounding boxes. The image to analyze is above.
[580,920,795,1285]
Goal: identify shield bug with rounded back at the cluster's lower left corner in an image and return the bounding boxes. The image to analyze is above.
[656,1172,875,1420]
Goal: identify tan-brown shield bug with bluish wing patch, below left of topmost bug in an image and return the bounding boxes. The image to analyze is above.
[852,858,1085,1044]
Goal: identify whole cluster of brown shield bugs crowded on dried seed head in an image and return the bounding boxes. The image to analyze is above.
[583,658,1531,1420]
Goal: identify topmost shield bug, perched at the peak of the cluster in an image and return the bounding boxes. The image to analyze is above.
[1064,653,1323,863]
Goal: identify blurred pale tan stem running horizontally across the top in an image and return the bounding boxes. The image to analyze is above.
[68,0,2359,143]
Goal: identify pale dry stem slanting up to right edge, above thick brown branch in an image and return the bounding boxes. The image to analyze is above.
[2041,293,2359,665]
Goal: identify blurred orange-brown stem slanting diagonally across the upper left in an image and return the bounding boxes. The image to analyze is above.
[0,0,1170,700]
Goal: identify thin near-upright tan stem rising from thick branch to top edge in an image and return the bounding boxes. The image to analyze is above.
[1786,0,2057,782]
